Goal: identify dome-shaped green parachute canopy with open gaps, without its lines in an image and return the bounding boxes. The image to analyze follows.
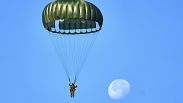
[42,0,103,34]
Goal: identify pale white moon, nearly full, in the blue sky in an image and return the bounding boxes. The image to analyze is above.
[108,79,131,99]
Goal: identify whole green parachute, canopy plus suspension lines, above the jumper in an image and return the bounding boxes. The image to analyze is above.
[42,0,103,83]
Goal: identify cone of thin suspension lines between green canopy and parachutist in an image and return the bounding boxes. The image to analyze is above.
[50,29,97,83]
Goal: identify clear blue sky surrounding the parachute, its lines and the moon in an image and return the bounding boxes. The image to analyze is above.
[0,0,183,103]
